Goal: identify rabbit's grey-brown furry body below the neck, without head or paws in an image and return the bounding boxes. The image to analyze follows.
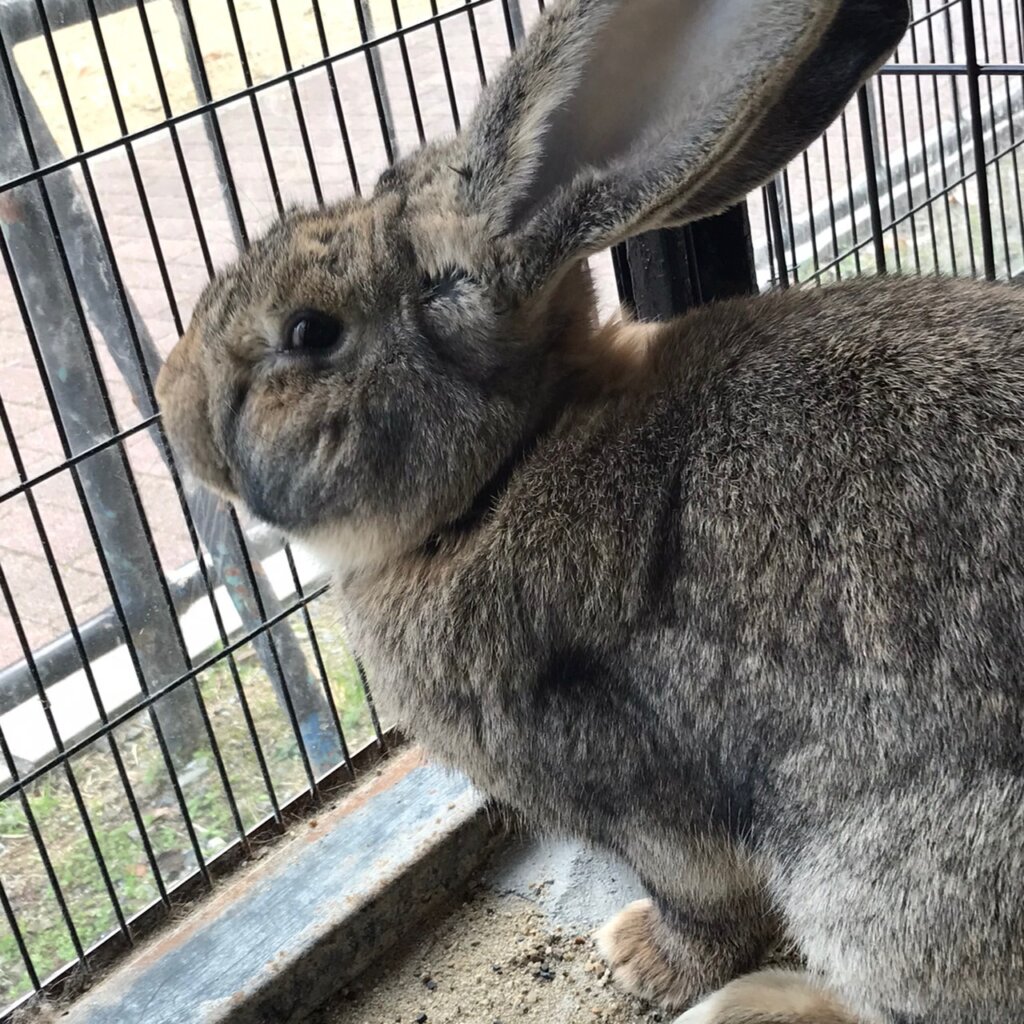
[339,281,1024,1024]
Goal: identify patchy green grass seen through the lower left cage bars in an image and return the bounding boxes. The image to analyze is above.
[0,606,373,1012]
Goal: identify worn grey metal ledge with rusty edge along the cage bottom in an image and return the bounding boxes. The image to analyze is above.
[54,750,495,1024]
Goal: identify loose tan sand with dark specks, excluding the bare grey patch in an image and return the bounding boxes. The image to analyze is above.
[315,891,673,1024]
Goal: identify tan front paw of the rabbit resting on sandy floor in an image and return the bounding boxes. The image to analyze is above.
[594,899,719,1010]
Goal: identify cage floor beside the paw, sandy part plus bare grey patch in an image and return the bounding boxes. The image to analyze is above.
[309,841,672,1024]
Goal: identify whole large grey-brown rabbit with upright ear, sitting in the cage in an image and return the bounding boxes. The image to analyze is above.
[151,0,1024,1024]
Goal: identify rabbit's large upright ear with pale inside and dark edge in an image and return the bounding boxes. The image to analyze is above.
[460,0,909,284]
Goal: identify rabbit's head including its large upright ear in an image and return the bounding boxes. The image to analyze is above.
[158,0,907,563]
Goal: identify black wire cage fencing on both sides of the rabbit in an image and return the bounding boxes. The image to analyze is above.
[0,0,1024,1016]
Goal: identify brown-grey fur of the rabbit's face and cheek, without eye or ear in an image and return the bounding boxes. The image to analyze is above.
[158,189,593,566]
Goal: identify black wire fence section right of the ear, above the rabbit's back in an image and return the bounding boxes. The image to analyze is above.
[750,0,1024,285]
